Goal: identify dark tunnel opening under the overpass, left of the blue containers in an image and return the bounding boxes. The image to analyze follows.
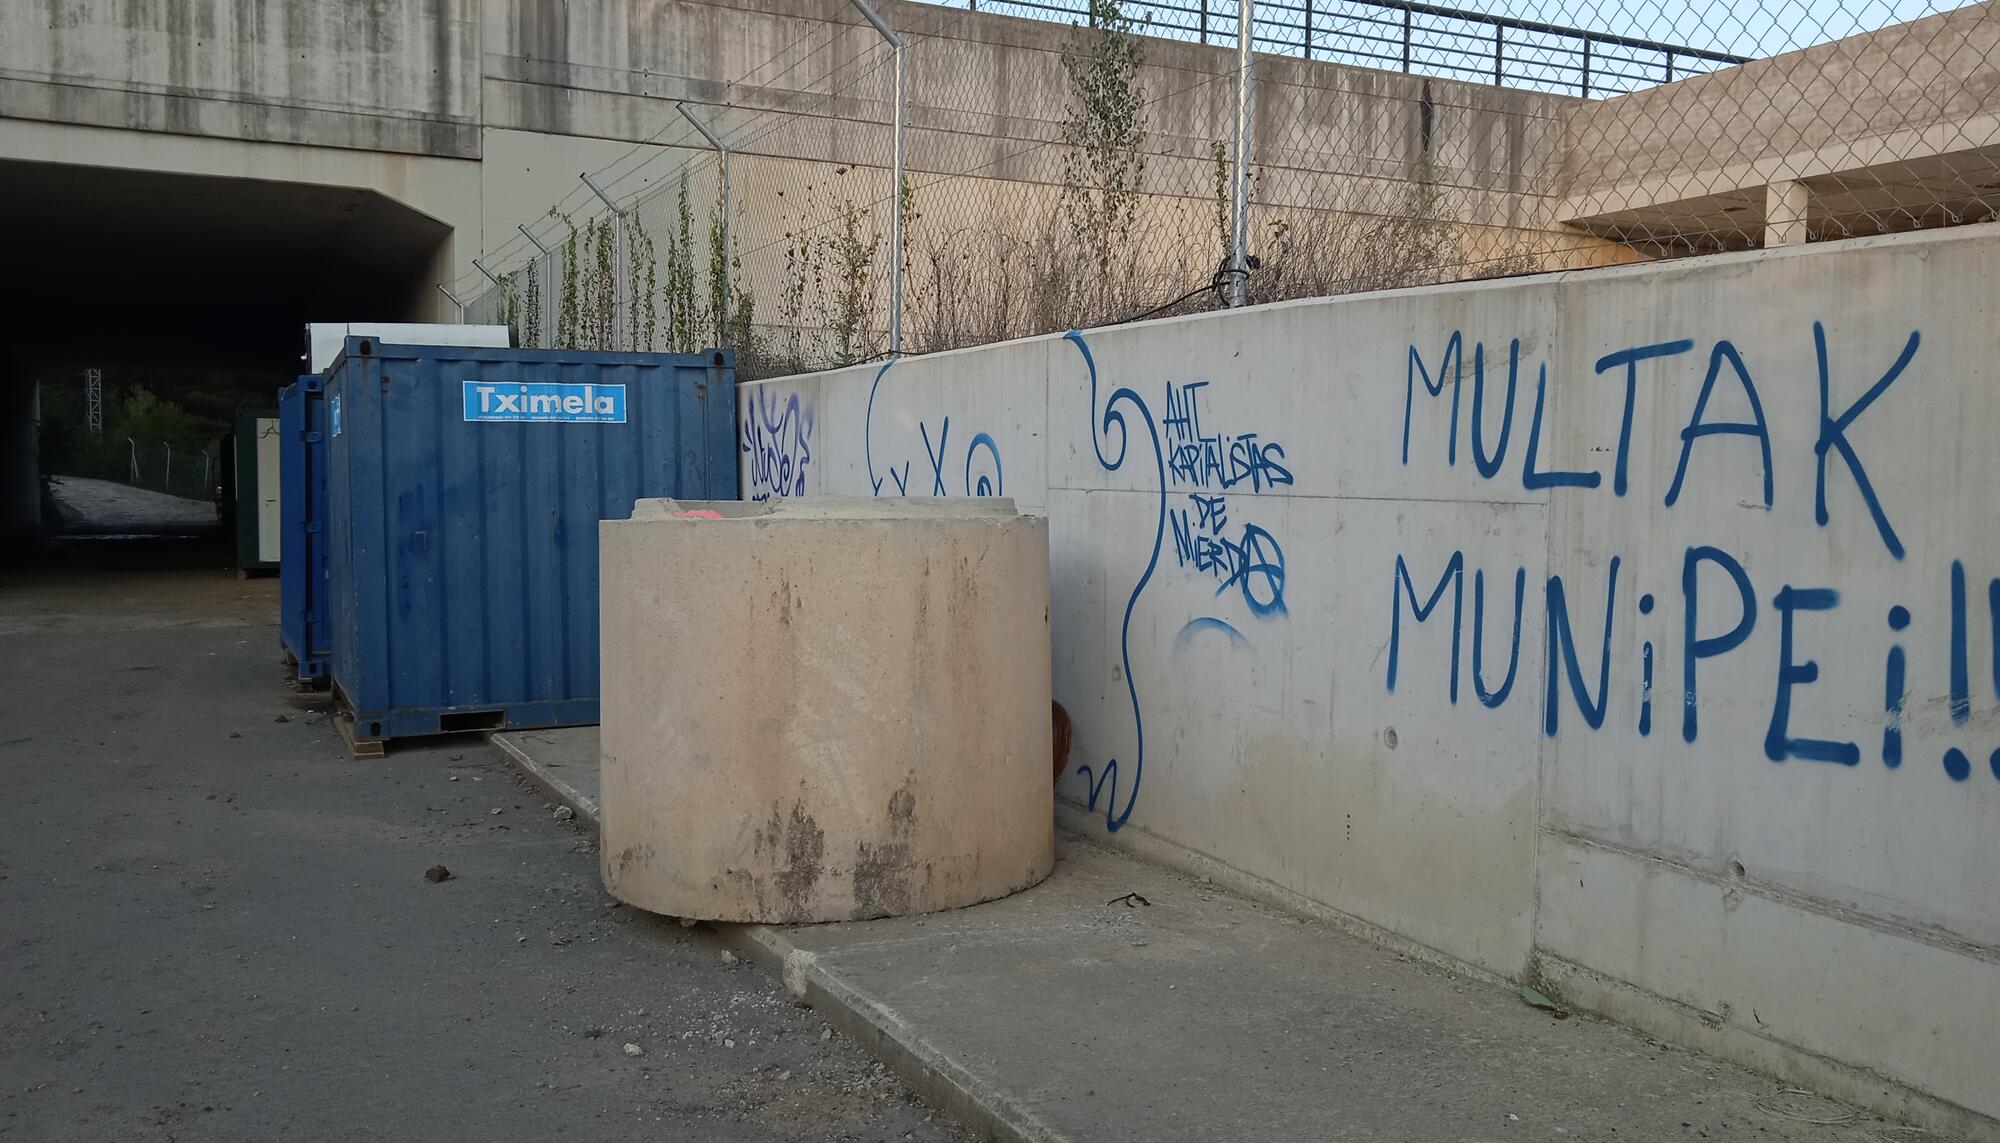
[0,160,452,552]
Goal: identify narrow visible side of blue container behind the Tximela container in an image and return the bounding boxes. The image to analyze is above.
[278,374,332,681]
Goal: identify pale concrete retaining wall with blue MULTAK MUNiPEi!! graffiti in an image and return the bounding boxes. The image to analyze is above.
[740,232,2000,1129]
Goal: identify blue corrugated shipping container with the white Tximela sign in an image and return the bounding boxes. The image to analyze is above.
[326,338,736,739]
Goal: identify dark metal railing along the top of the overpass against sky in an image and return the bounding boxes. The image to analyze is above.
[934,0,1746,98]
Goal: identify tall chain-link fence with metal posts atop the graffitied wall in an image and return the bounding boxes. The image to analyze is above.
[454,0,2000,376]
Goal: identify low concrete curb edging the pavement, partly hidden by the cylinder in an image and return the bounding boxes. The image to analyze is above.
[486,733,1072,1143]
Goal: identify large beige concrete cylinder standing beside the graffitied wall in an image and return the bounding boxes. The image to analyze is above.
[598,498,1056,923]
